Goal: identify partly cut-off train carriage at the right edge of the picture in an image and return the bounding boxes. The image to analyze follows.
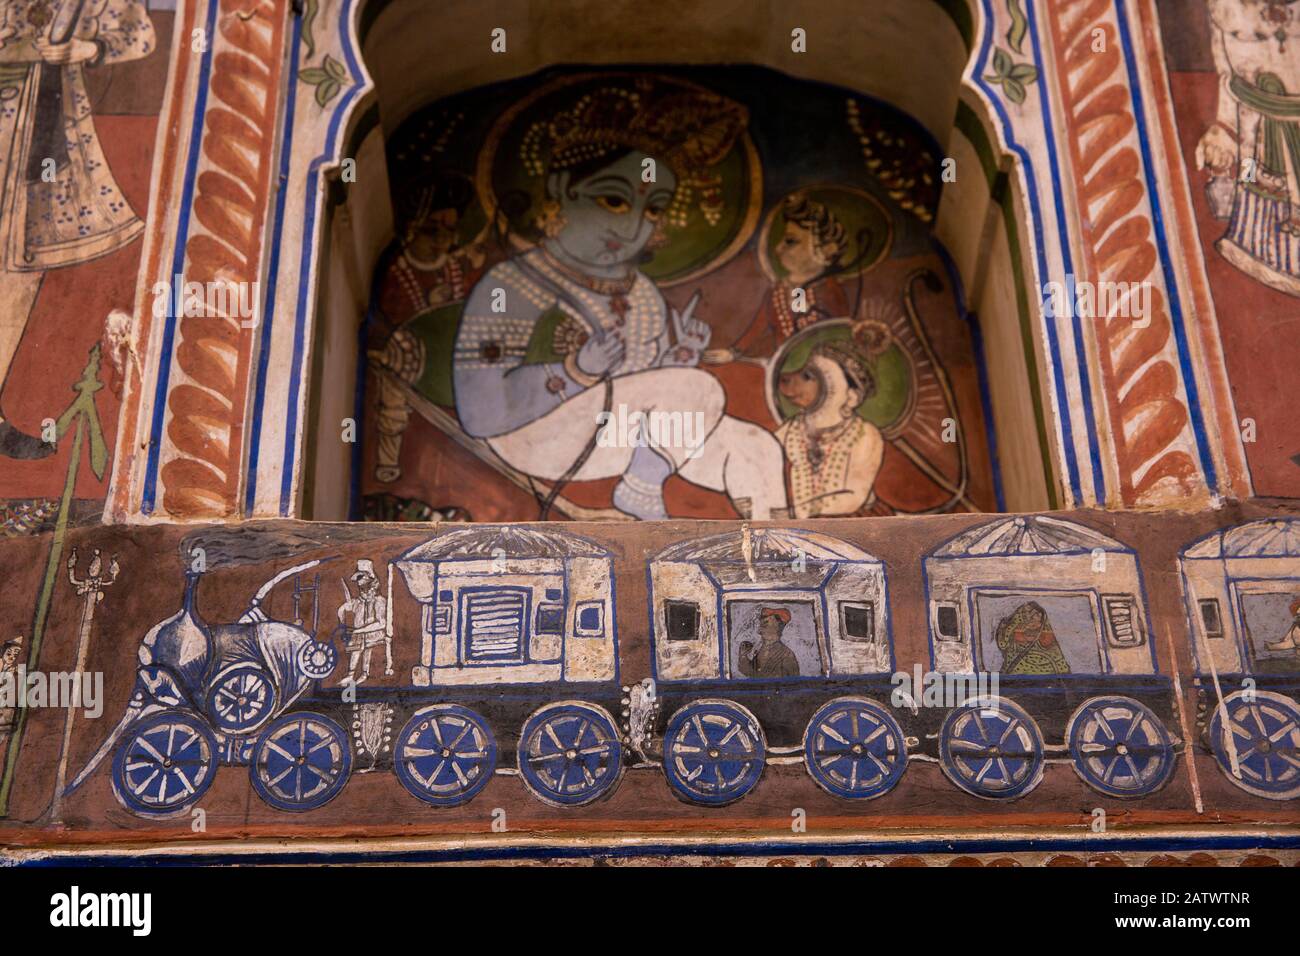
[1179,519,1300,800]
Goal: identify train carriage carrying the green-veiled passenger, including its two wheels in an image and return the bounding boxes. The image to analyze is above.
[923,516,1179,799]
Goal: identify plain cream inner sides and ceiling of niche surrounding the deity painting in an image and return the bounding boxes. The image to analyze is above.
[299,0,1058,519]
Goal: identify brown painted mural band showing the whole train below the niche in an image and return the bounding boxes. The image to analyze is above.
[0,506,1300,844]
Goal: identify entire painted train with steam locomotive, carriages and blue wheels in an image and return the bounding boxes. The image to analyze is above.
[68,516,1300,817]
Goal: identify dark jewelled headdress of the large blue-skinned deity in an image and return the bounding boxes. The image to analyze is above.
[520,77,749,228]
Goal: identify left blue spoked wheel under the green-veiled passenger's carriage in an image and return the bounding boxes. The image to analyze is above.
[939,697,1043,800]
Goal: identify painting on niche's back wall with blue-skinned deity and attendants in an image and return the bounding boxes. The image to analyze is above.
[361,68,997,520]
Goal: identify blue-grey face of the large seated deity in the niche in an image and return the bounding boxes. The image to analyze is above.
[547,151,677,274]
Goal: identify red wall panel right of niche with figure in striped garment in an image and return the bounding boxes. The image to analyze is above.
[1161,0,1300,497]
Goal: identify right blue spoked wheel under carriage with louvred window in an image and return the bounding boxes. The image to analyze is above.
[519,701,623,806]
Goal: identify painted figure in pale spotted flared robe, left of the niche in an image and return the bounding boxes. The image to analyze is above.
[0,0,155,458]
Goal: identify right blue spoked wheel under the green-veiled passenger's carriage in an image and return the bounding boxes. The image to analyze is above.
[1065,697,1174,797]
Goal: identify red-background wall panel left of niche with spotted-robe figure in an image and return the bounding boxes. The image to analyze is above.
[0,0,173,536]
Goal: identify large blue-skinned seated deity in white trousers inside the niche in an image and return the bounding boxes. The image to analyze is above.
[454,82,785,519]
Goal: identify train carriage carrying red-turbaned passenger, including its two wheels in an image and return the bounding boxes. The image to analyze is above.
[647,528,909,806]
